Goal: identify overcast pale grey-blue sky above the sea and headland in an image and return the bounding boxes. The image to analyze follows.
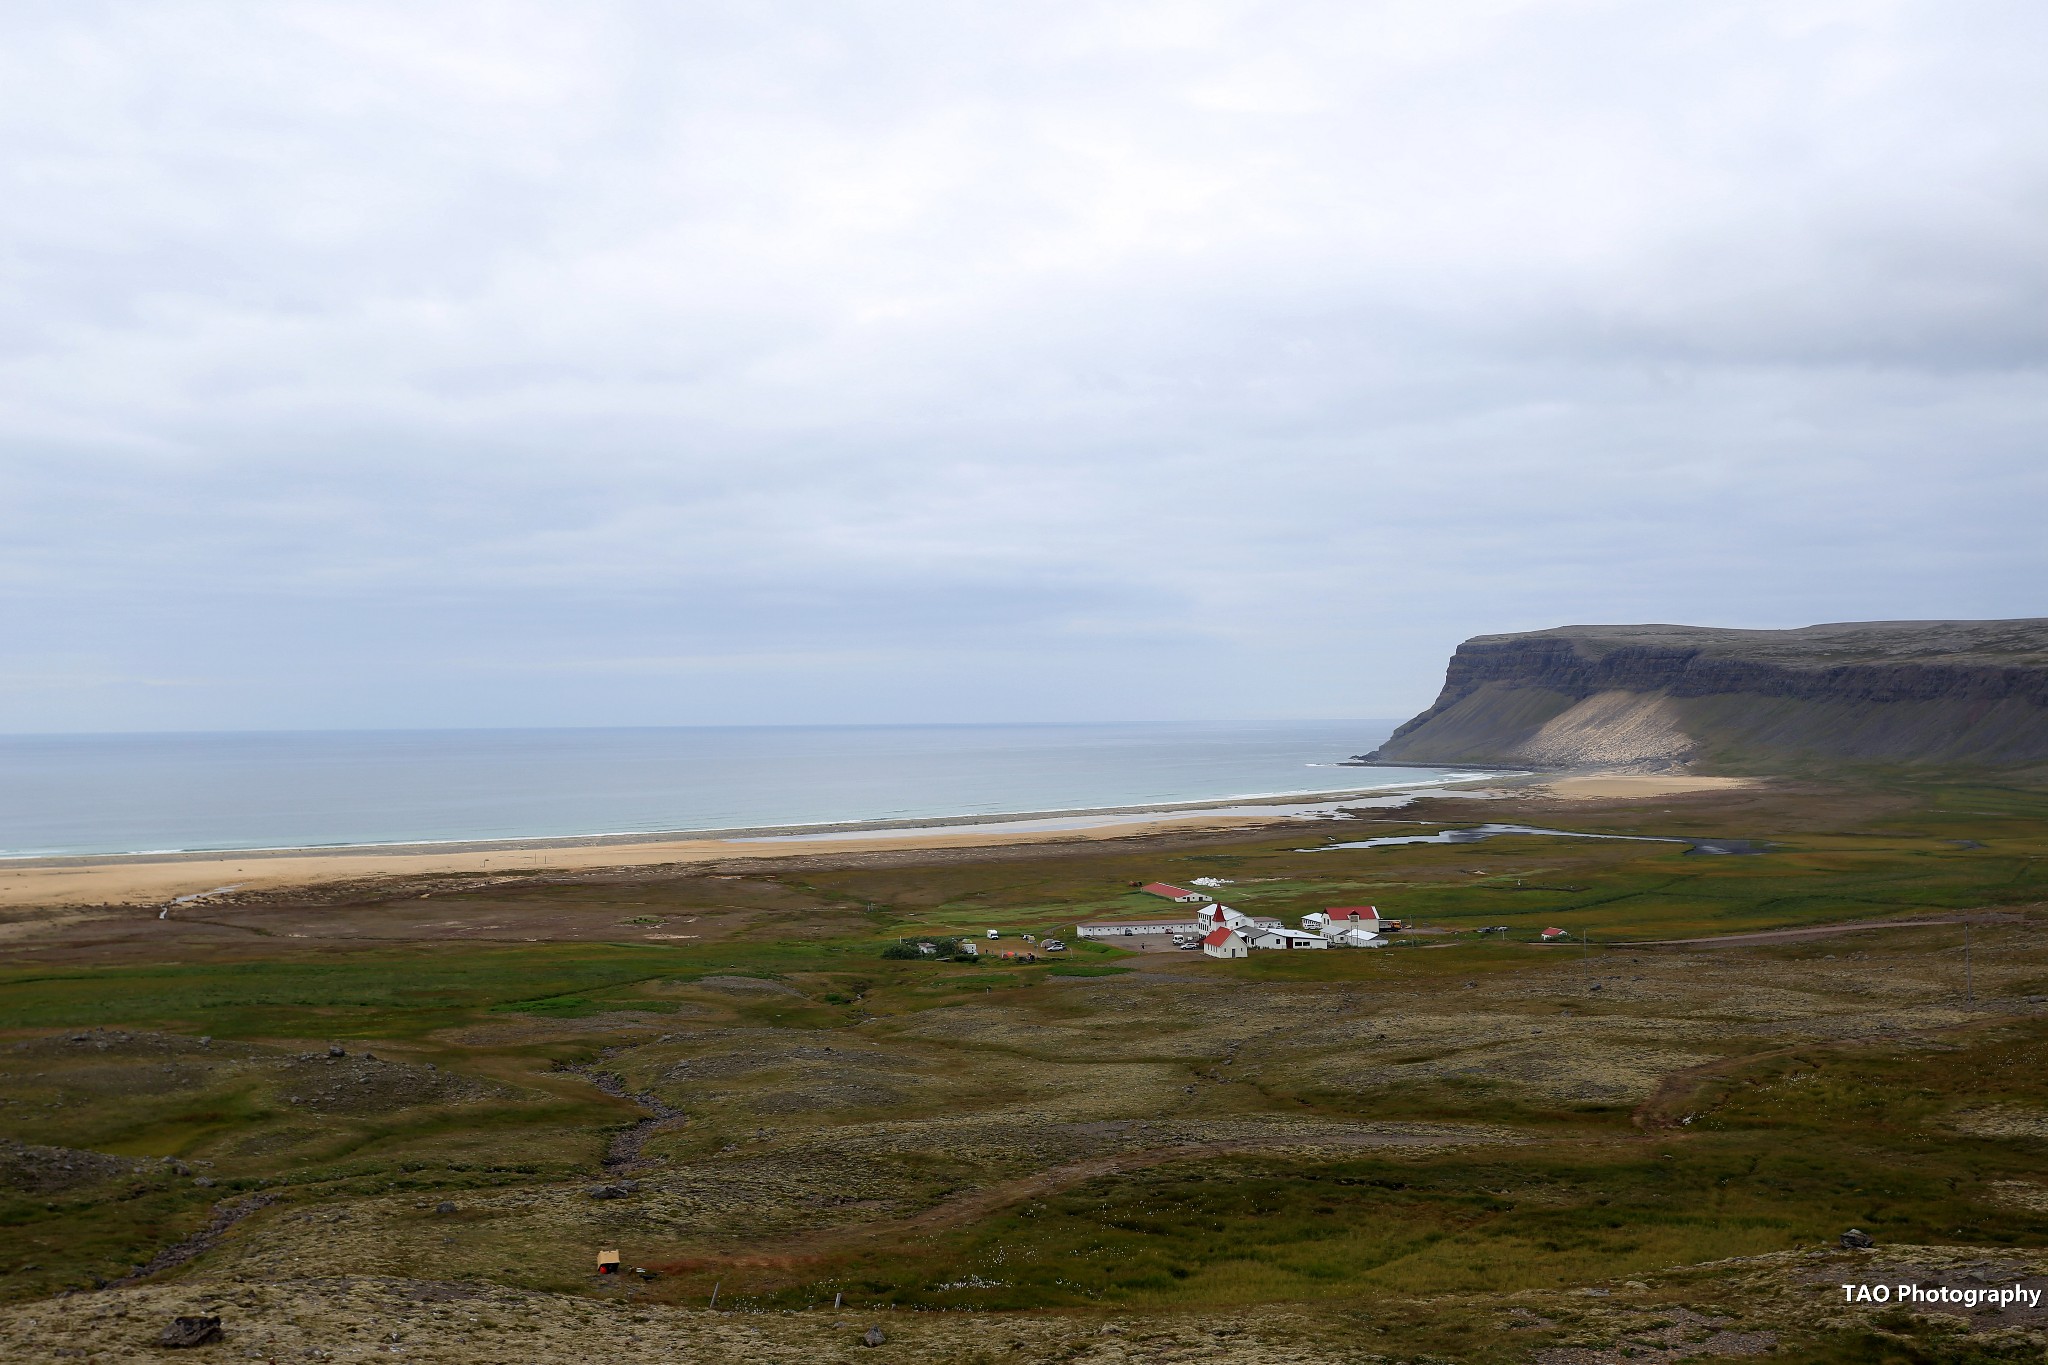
[0,0,2048,731]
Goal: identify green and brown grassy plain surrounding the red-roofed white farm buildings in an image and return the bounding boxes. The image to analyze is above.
[0,780,2048,1361]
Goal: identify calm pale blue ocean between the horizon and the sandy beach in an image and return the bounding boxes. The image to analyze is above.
[0,720,1444,857]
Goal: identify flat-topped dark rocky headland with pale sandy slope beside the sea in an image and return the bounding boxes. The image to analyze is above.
[1364,618,2048,772]
